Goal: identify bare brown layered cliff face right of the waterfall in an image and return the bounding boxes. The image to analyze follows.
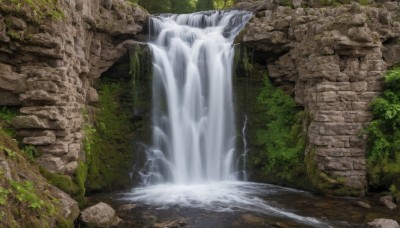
[239,1,400,195]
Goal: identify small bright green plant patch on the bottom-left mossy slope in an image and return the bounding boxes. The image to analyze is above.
[11,181,45,210]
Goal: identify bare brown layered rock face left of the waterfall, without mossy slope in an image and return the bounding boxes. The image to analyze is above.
[0,0,148,175]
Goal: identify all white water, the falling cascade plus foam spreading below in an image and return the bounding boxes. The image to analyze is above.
[131,11,328,226]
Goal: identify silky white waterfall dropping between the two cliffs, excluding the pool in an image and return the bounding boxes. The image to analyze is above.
[141,10,251,184]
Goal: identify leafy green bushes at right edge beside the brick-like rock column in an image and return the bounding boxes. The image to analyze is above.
[366,67,400,195]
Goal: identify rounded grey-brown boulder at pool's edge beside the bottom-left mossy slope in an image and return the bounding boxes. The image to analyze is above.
[80,202,121,227]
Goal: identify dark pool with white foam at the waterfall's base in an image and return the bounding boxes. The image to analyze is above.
[89,182,400,227]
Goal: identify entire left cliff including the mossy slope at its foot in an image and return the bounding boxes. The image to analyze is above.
[0,0,148,227]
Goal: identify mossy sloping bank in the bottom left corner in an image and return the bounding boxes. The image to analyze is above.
[0,124,72,228]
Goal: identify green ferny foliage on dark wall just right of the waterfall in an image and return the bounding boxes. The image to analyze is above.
[253,76,307,185]
